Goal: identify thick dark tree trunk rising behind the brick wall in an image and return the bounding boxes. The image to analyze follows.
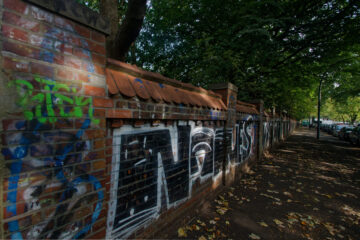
[80,0,146,61]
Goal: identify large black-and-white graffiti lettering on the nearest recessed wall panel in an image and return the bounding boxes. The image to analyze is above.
[107,121,237,238]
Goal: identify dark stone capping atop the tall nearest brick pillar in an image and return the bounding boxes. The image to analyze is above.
[24,0,110,35]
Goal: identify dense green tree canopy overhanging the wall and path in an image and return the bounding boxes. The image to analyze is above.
[79,0,360,118]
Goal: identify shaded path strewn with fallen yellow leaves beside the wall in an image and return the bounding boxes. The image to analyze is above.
[167,129,360,240]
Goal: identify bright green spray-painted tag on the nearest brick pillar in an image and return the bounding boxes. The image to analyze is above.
[9,77,100,124]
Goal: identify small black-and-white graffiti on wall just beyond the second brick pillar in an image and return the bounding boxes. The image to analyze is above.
[238,116,255,162]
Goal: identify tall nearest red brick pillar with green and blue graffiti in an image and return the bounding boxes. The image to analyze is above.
[0,0,109,239]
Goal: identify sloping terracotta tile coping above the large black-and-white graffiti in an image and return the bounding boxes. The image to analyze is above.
[106,59,226,110]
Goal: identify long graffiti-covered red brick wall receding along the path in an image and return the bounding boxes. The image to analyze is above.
[0,0,296,239]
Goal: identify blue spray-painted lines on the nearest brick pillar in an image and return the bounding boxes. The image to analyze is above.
[2,25,104,239]
